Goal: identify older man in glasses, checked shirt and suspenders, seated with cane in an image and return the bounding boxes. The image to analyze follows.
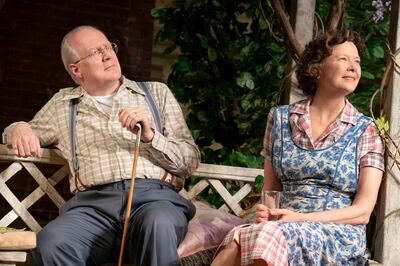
[3,26,200,266]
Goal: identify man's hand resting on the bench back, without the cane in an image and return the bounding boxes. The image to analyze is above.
[11,123,42,158]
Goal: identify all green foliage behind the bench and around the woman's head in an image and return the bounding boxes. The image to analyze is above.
[152,0,389,205]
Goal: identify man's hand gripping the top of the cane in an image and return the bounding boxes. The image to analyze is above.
[118,107,154,142]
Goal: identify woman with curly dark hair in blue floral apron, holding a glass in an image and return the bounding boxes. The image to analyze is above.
[213,30,384,265]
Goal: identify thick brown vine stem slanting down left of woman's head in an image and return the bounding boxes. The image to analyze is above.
[271,0,304,62]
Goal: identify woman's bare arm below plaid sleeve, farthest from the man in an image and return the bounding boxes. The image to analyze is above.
[271,167,383,225]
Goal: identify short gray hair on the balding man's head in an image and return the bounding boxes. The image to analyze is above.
[61,25,105,85]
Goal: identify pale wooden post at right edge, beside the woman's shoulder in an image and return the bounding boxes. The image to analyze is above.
[375,1,400,265]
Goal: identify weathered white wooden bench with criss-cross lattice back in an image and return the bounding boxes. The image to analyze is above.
[0,144,379,266]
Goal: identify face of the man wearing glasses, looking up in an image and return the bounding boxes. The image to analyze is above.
[69,28,121,95]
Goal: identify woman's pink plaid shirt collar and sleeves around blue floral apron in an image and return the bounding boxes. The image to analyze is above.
[261,98,385,171]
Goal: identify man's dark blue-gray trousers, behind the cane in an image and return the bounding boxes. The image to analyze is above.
[32,179,195,266]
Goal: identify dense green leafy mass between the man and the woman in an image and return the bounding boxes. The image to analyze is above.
[152,0,288,163]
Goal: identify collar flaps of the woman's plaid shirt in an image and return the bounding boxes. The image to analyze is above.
[290,97,360,125]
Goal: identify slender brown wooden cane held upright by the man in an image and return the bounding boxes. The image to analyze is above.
[118,124,142,266]
